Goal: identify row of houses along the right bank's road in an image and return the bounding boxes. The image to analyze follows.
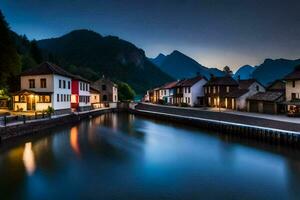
[144,67,300,115]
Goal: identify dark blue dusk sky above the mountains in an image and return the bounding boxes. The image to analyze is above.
[0,0,300,68]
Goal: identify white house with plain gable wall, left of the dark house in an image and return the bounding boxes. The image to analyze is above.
[176,76,207,106]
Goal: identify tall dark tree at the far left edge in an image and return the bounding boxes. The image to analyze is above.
[0,10,21,87]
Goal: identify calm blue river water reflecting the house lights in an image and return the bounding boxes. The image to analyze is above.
[0,114,300,200]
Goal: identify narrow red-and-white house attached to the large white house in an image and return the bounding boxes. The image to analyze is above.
[71,75,91,111]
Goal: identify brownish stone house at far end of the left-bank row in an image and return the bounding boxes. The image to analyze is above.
[92,76,118,103]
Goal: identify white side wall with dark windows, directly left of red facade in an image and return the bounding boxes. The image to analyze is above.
[51,75,72,110]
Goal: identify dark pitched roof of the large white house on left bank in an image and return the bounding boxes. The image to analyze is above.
[21,62,73,78]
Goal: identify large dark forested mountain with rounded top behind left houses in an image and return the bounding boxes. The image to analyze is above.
[38,30,173,93]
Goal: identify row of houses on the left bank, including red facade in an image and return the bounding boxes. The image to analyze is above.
[12,62,118,114]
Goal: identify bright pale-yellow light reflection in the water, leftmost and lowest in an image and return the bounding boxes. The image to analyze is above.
[23,142,36,176]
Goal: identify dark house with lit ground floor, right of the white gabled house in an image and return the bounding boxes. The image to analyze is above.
[204,76,239,108]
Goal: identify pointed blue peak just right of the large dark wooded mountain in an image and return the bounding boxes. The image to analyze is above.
[150,50,224,79]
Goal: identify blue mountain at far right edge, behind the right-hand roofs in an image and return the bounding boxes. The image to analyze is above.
[252,59,300,85]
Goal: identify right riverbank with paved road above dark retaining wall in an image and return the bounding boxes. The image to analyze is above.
[131,103,300,146]
